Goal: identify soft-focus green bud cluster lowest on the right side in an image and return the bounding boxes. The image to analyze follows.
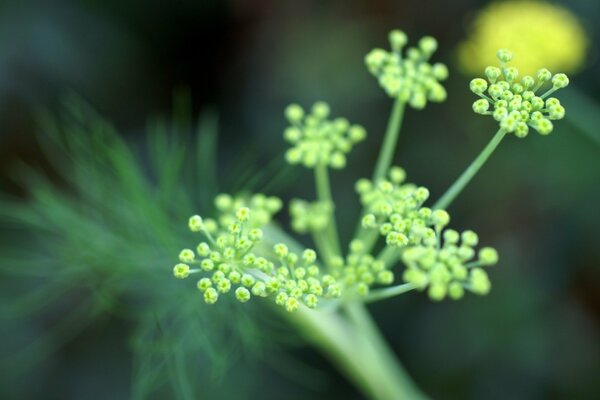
[402,229,498,301]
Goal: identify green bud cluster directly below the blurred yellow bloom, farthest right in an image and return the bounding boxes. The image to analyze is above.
[470,50,569,138]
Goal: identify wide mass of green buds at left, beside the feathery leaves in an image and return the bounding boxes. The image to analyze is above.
[173,195,341,312]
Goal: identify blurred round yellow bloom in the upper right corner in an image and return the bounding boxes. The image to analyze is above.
[458,0,587,75]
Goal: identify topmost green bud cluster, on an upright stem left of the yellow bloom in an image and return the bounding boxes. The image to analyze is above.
[365,30,448,109]
